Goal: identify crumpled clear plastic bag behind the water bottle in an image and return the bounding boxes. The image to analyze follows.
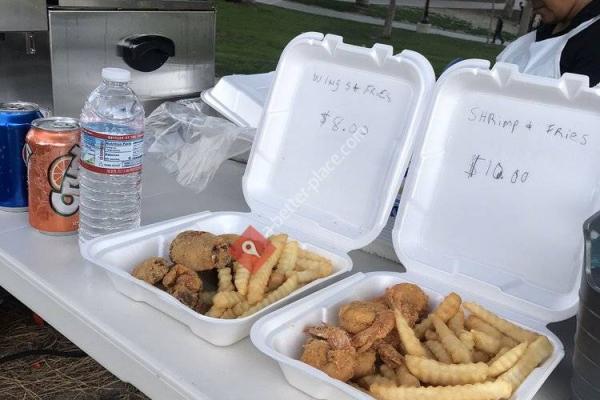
[145,100,255,192]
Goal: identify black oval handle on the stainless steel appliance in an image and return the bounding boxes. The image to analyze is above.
[117,35,175,72]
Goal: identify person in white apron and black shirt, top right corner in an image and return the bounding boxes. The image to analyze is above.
[497,0,600,86]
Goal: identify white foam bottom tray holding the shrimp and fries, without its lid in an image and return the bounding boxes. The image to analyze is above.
[251,272,564,400]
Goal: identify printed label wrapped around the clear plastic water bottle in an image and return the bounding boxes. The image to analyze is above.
[81,129,144,175]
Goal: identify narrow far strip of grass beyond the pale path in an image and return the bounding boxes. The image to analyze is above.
[284,0,515,40]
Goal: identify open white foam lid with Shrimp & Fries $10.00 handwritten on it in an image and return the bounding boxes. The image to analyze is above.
[394,60,600,325]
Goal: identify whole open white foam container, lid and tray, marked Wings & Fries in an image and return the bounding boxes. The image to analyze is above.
[82,33,435,346]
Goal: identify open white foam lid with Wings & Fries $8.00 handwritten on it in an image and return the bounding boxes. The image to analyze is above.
[243,33,435,252]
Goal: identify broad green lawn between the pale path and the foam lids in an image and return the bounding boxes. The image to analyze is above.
[216,0,501,76]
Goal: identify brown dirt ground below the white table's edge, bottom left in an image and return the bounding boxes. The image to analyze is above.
[0,288,148,400]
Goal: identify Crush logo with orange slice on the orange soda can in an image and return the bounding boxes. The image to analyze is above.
[48,144,80,217]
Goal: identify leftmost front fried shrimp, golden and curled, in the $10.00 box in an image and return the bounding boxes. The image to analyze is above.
[300,325,357,382]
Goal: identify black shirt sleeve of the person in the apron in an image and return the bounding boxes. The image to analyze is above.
[560,21,600,86]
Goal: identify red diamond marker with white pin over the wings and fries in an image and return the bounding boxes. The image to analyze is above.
[229,226,275,273]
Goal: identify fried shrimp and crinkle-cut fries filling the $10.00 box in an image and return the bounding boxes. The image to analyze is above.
[301,284,554,400]
